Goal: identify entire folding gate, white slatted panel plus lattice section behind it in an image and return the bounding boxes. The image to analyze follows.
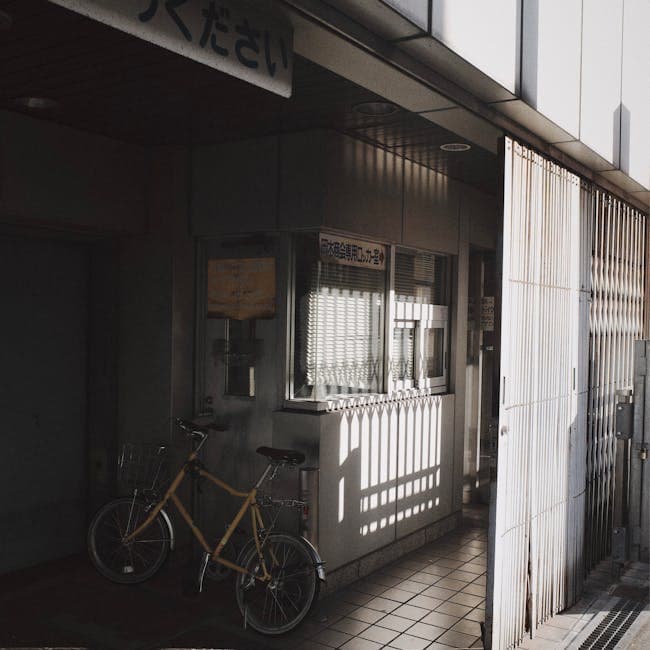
[487,139,647,648]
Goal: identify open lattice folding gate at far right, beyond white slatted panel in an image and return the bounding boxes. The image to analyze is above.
[586,190,646,568]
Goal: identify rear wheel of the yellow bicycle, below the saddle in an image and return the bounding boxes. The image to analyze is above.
[235,533,319,635]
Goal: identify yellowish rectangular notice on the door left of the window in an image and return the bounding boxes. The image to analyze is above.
[208,257,275,320]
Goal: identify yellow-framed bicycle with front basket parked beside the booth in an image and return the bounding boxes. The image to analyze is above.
[88,418,325,635]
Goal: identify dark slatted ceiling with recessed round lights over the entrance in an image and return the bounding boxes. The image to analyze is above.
[0,0,497,193]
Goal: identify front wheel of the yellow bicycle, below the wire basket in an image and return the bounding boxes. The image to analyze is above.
[87,497,170,584]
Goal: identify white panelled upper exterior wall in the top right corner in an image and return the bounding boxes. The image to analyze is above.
[352,0,650,196]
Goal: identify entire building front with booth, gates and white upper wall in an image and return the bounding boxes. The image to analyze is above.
[0,0,650,648]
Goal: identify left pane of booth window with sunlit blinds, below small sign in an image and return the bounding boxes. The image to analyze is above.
[293,230,386,400]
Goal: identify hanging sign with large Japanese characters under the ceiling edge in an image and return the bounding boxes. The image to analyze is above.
[50,0,293,97]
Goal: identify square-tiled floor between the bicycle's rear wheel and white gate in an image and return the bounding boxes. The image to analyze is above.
[297,527,487,650]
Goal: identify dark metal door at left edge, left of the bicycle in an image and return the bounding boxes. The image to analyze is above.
[0,237,88,573]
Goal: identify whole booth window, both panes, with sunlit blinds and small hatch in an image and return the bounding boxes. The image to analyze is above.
[291,233,448,401]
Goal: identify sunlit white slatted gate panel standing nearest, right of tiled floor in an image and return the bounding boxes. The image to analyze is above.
[488,139,589,648]
